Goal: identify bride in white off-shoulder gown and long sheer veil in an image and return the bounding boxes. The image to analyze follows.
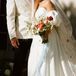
[28,0,76,76]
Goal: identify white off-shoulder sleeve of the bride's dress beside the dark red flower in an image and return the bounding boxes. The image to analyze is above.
[47,10,61,27]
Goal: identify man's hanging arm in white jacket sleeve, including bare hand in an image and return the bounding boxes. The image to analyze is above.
[6,0,19,48]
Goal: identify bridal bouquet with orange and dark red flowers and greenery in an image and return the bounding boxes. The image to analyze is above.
[33,16,53,43]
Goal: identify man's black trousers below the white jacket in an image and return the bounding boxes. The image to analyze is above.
[12,39,32,76]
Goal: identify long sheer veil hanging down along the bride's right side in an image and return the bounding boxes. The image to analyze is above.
[50,0,76,64]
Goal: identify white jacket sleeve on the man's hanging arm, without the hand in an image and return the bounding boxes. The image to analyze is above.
[6,0,16,39]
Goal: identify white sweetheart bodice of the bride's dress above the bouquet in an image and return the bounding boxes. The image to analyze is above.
[35,6,58,24]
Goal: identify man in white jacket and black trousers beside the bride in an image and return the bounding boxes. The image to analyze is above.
[6,0,32,76]
